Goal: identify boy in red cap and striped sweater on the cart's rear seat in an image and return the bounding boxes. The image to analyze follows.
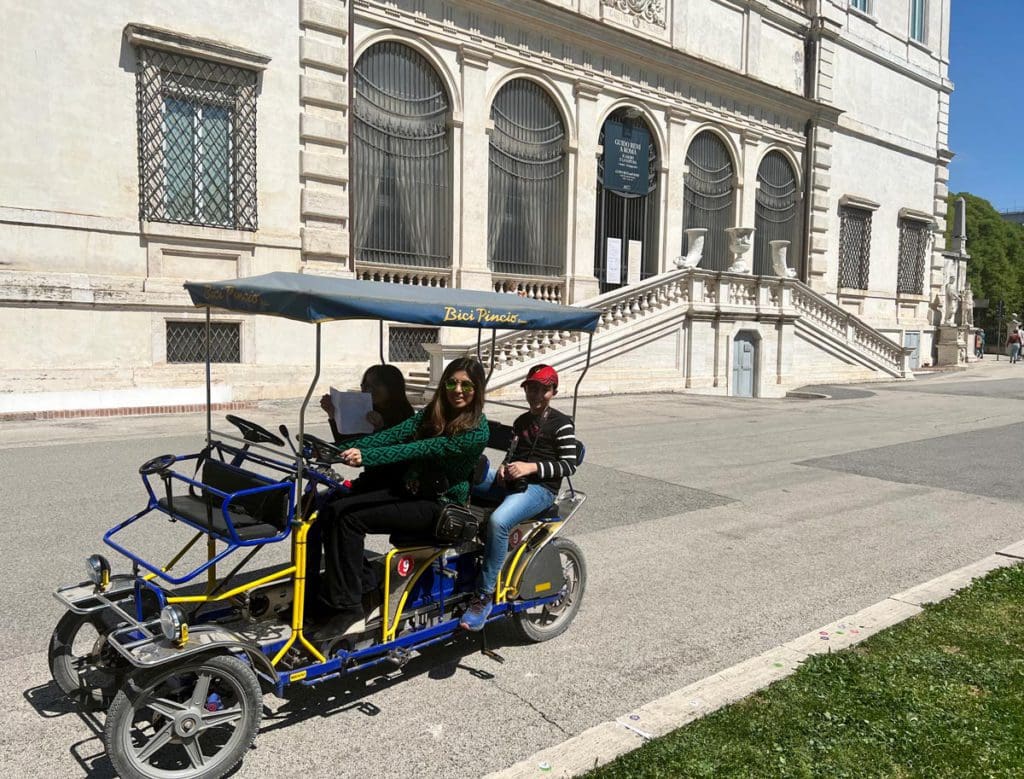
[460,364,577,631]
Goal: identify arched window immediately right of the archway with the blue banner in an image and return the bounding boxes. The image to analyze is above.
[683,130,735,270]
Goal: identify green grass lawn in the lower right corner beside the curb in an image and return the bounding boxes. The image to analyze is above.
[588,566,1024,779]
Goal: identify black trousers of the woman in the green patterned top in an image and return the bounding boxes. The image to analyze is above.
[316,489,440,610]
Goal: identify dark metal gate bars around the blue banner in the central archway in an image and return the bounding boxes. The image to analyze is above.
[594,109,660,292]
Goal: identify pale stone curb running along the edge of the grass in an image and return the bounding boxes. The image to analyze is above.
[485,540,1024,779]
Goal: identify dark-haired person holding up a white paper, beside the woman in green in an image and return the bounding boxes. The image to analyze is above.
[321,365,413,442]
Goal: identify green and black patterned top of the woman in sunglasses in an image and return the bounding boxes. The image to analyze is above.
[344,410,489,505]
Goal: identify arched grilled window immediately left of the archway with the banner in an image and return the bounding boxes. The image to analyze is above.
[487,79,566,275]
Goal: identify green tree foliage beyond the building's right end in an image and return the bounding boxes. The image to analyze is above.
[946,192,1024,316]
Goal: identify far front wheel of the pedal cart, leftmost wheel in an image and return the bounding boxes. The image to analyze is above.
[47,609,131,710]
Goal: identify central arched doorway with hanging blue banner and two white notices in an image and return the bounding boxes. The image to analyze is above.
[594,109,658,292]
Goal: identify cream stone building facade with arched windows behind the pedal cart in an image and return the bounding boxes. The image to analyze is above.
[0,0,952,413]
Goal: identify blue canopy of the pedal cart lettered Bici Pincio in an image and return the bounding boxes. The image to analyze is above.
[185,272,601,333]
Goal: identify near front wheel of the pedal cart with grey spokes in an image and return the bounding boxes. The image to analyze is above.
[103,655,263,779]
